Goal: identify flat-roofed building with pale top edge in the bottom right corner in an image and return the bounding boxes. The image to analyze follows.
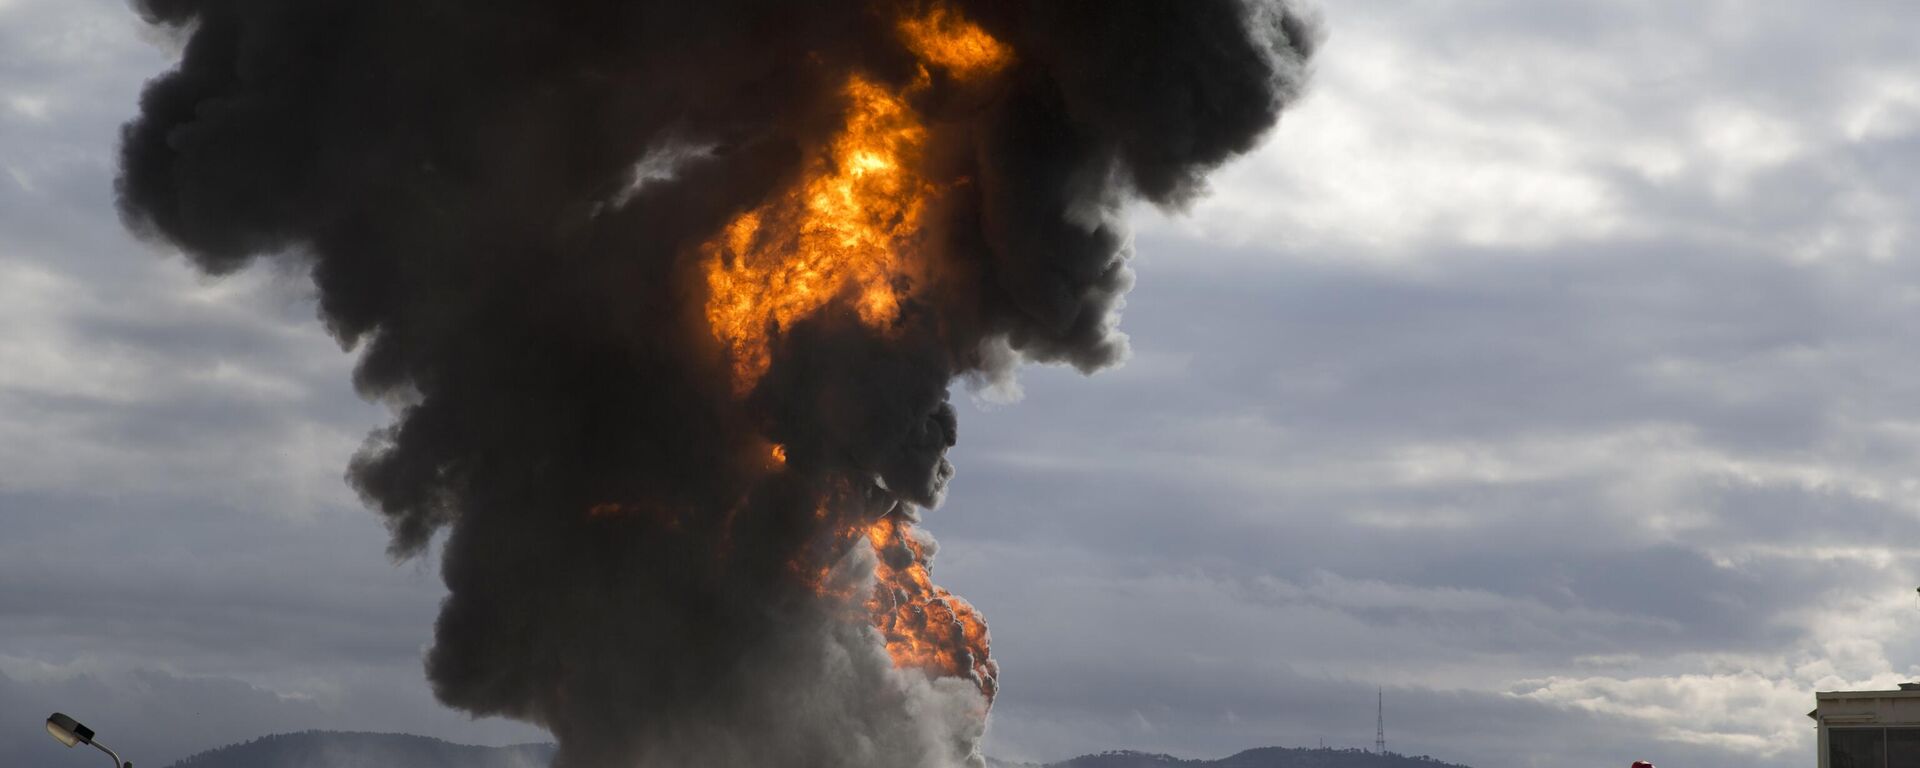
[1807,684,1920,768]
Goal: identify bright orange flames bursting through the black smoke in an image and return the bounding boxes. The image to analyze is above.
[701,6,1012,701]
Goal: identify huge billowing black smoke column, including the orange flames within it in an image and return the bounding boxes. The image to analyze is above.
[119,0,1317,768]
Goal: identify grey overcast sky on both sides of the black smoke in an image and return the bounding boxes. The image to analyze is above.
[0,0,1920,768]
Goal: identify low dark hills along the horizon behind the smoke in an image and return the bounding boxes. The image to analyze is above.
[169,732,1467,768]
